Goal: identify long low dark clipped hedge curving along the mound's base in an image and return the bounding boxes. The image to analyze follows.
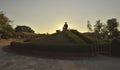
[11,42,93,53]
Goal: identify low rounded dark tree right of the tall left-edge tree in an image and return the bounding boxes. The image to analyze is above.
[15,26,34,33]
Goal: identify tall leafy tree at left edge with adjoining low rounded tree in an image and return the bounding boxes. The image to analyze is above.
[0,11,34,37]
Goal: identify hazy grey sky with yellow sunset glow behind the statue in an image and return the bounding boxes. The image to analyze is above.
[0,0,120,33]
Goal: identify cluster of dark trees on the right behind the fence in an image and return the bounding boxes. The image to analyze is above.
[87,18,119,39]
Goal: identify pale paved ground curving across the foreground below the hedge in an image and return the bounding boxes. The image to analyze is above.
[0,40,120,70]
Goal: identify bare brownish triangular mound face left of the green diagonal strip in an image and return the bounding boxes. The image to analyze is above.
[33,32,76,44]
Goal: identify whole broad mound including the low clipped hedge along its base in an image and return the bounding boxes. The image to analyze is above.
[11,30,109,53]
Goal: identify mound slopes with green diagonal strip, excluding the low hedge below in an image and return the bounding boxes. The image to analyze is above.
[32,30,92,44]
